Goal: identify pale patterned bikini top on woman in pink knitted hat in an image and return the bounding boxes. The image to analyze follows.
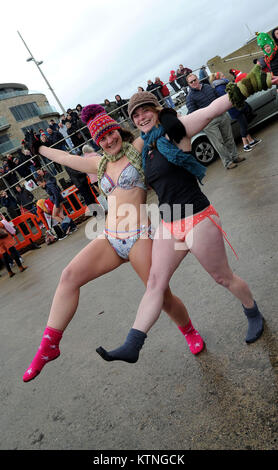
[100,163,147,196]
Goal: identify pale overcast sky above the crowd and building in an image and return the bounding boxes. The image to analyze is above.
[0,0,278,111]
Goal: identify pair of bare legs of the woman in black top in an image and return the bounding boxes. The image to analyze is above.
[130,217,260,344]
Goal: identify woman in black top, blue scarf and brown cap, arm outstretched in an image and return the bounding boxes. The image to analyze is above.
[98,70,278,362]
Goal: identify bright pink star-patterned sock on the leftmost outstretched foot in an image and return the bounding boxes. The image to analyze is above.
[23,326,63,382]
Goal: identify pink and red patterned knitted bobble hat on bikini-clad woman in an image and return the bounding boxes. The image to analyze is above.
[81,104,121,145]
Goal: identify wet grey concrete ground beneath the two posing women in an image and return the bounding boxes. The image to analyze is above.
[0,121,278,450]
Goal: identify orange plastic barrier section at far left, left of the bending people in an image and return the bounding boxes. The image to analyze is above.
[12,212,43,250]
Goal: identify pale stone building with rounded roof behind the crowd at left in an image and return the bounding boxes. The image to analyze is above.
[0,83,60,155]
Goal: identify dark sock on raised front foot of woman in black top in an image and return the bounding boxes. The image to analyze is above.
[96,328,147,363]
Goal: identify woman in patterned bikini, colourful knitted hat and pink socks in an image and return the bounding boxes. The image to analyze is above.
[23,103,204,382]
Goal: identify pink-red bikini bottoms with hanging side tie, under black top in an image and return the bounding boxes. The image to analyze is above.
[162,204,238,258]
